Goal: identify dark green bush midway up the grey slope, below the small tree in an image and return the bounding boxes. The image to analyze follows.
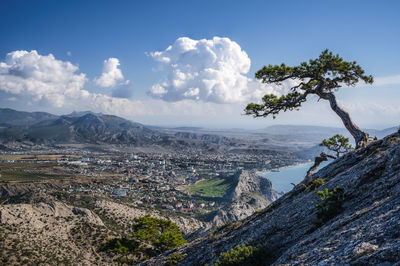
[315,187,344,222]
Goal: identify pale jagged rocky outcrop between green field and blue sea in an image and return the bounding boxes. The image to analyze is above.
[213,171,278,226]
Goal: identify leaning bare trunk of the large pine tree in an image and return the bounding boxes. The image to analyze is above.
[317,92,369,149]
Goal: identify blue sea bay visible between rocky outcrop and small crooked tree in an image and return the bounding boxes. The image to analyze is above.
[259,161,330,193]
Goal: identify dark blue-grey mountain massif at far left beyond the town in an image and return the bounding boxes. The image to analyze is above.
[0,109,161,146]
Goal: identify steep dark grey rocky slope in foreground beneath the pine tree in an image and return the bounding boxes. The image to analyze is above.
[143,133,400,265]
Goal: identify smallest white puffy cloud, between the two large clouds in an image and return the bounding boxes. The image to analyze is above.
[94,57,129,88]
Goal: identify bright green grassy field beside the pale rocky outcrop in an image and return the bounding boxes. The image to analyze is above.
[187,178,232,198]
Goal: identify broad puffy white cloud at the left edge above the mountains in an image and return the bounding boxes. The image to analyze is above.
[0,50,89,106]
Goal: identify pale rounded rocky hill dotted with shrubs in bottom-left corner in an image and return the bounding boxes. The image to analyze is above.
[0,202,113,265]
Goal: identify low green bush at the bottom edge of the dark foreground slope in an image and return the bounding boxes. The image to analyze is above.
[214,244,271,266]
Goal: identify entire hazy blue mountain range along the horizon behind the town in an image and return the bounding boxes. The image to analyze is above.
[0,108,397,153]
